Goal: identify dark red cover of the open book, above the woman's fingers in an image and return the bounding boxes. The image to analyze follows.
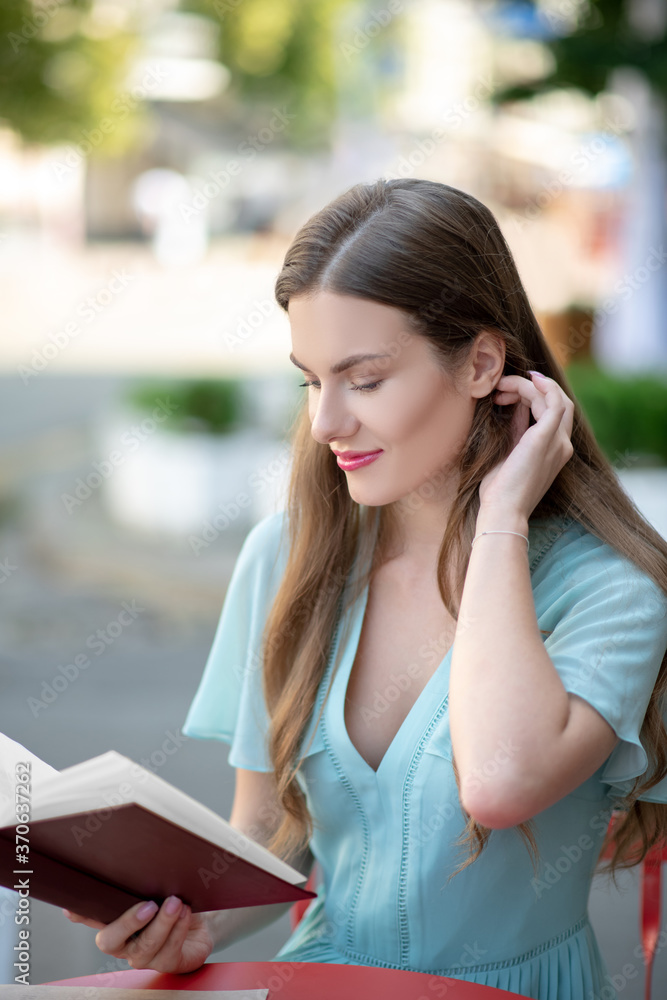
[0,803,316,923]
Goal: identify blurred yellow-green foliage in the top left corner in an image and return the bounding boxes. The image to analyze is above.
[0,0,138,151]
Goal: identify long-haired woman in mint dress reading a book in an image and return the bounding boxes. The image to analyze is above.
[65,179,667,1000]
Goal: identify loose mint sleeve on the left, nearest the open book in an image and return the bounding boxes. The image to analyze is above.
[183,511,287,771]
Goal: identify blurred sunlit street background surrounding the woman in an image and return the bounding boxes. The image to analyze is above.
[0,0,667,1000]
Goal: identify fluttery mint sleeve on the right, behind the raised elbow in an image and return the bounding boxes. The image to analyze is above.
[544,526,667,802]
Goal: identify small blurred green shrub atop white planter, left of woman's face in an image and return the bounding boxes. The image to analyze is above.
[127,378,244,434]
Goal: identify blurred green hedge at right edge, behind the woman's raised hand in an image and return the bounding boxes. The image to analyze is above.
[565,362,667,467]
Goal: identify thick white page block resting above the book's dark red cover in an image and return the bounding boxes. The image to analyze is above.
[26,750,306,885]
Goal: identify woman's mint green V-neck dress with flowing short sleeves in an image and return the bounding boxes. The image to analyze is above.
[184,511,667,1000]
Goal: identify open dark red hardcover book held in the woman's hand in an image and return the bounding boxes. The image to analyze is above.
[0,750,315,923]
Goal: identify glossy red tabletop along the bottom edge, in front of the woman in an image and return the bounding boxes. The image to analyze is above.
[46,962,525,1000]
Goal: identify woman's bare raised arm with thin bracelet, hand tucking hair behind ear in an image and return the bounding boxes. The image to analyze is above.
[449,375,618,828]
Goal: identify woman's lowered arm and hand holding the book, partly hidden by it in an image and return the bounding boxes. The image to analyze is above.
[68,768,313,973]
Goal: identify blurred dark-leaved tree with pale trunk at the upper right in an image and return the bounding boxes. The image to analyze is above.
[494,0,667,372]
